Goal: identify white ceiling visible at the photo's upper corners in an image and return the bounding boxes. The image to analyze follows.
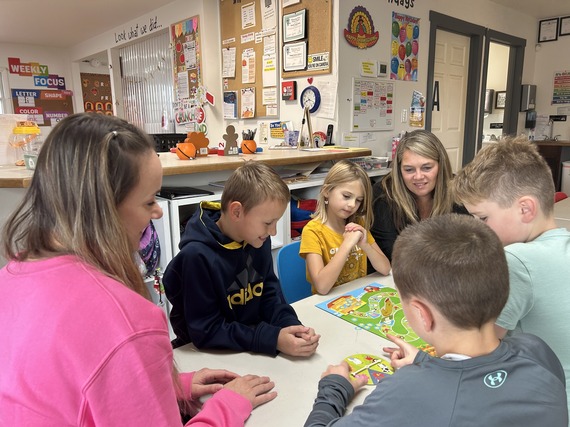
[0,0,570,48]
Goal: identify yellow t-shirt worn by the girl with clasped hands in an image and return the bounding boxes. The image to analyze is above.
[299,219,374,294]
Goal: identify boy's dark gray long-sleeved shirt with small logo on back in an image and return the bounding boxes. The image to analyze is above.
[305,334,568,427]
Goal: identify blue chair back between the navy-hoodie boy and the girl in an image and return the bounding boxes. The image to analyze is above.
[277,241,312,304]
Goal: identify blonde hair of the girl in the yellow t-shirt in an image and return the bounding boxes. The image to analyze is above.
[313,160,374,230]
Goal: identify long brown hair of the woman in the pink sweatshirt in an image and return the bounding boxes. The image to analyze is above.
[2,113,154,299]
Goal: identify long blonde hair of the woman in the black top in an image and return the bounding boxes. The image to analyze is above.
[381,130,453,231]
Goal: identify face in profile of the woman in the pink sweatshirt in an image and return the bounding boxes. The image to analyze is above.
[118,151,162,250]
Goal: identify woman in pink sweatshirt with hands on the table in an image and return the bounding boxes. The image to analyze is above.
[0,113,276,426]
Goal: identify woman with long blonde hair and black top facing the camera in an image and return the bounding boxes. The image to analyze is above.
[369,129,467,262]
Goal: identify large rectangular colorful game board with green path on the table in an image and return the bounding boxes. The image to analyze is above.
[316,283,433,353]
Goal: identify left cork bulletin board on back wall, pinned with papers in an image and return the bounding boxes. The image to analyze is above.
[220,0,280,119]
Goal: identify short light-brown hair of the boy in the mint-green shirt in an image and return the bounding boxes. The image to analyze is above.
[451,137,554,215]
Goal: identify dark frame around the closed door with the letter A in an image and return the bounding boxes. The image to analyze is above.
[425,10,486,166]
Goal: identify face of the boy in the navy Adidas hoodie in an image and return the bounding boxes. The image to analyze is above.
[234,200,287,248]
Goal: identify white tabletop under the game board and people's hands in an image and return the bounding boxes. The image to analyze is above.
[174,273,394,427]
